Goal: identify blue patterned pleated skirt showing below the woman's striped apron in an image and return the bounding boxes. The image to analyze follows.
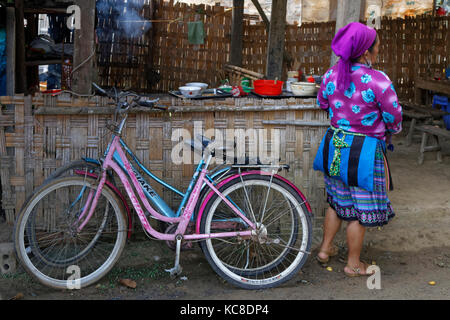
[325,145,395,227]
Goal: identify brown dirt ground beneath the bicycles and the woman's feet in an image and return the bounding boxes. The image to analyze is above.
[0,130,450,301]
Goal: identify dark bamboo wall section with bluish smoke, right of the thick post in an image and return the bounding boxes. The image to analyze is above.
[96,0,155,92]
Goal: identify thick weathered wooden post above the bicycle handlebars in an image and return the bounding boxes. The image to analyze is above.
[72,0,95,94]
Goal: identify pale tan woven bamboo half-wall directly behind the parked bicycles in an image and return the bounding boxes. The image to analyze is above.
[0,97,328,242]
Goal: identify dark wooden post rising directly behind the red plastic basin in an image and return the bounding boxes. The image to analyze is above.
[266,0,287,80]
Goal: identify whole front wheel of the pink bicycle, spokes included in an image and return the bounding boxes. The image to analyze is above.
[14,177,127,289]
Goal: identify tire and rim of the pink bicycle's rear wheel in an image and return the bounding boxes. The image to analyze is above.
[200,174,312,289]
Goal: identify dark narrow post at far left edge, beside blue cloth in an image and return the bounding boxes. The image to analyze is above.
[6,7,16,96]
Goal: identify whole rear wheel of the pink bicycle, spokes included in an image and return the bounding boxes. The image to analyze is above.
[201,174,312,289]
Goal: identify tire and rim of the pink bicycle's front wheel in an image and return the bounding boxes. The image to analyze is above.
[14,177,127,289]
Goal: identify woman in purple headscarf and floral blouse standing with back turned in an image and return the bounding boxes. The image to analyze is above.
[315,22,402,276]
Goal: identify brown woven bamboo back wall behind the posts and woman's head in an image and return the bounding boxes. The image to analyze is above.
[93,0,450,100]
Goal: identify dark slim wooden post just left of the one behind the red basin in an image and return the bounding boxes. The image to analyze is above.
[230,0,244,66]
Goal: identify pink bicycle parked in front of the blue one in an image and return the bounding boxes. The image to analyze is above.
[14,85,312,289]
